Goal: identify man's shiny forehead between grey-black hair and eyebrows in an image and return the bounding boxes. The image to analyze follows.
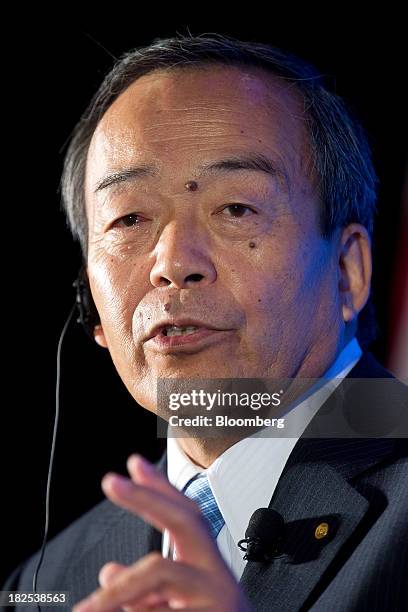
[87,66,308,185]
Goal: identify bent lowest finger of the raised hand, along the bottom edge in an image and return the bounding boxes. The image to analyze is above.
[73,553,211,612]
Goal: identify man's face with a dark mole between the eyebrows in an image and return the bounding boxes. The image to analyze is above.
[86,67,342,410]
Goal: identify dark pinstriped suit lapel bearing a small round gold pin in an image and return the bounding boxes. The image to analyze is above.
[241,464,368,612]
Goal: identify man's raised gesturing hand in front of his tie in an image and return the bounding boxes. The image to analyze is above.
[73,455,250,612]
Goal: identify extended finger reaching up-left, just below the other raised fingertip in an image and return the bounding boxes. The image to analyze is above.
[102,473,220,568]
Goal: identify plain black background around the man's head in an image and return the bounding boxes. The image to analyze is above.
[0,15,407,580]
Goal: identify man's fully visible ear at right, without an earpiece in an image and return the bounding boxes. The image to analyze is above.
[339,223,372,323]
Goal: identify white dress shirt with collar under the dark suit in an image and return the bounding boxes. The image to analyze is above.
[162,338,362,580]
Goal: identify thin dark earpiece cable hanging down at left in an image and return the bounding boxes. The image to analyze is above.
[33,303,77,612]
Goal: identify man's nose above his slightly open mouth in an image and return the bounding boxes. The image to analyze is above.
[150,220,217,289]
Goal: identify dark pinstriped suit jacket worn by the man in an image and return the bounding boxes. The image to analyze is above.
[3,353,408,612]
